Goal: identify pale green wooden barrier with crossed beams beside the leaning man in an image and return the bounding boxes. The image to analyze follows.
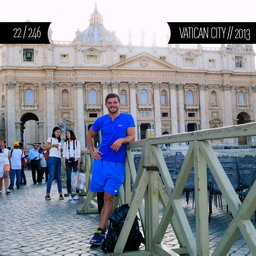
[78,123,256,256]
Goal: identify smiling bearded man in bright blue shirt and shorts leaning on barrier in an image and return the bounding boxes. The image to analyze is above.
[86,93,135,246]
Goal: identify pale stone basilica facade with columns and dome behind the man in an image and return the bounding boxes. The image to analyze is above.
[0,8,256,148]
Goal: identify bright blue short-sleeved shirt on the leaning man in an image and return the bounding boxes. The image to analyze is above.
[92,113,135,162]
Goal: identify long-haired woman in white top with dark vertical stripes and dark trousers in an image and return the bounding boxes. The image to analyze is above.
[63,130,81,201]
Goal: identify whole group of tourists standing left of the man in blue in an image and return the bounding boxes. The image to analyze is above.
[0,127,81,201]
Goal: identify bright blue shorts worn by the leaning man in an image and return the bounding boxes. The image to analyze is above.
[90,160,125,196]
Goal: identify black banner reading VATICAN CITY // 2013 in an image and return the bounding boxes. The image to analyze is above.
[167,22,256,44]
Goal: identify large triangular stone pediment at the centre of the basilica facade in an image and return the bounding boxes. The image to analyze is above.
[110,53,177,70]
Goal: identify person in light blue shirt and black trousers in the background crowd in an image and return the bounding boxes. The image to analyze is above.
[28,143,42,184]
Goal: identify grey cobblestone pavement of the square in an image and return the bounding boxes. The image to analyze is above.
[0,171,255,256]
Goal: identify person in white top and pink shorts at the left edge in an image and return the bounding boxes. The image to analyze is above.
[0,140,10,194]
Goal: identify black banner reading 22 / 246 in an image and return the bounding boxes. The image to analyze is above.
[0,22,51,44]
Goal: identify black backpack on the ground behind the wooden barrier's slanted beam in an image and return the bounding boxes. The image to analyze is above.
[101,204,145,253]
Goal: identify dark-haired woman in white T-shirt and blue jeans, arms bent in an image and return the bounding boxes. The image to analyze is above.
[44,126,64,200]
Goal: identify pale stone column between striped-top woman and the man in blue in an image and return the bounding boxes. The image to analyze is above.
[74,82,85,149]
